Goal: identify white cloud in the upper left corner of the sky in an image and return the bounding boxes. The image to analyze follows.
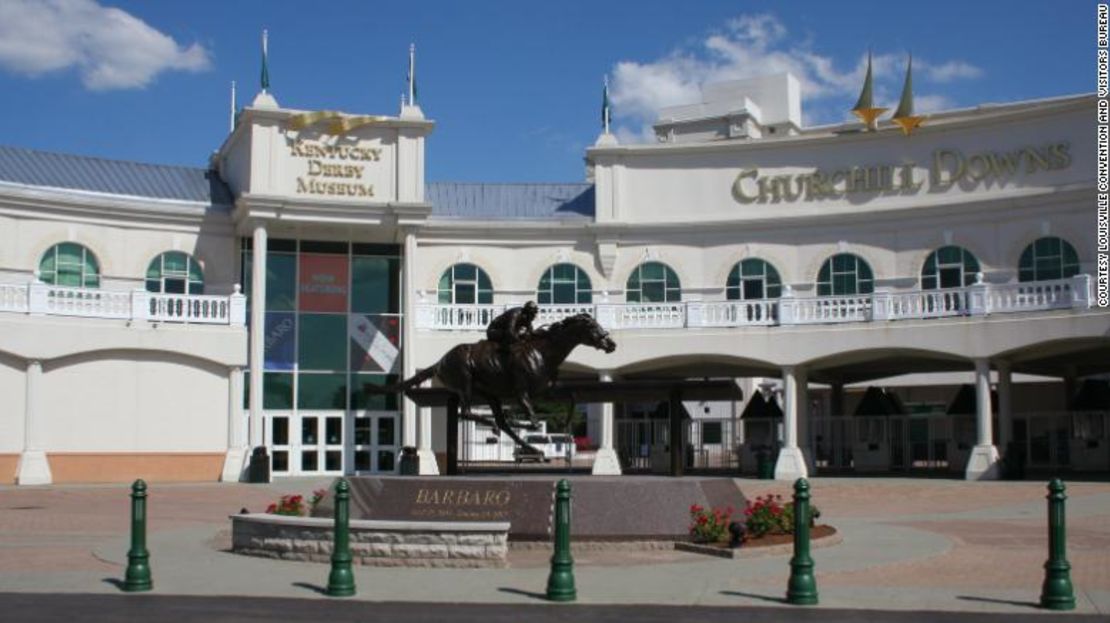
[0,0,211,91]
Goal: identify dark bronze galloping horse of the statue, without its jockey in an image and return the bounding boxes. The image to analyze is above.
[388,313,617,446]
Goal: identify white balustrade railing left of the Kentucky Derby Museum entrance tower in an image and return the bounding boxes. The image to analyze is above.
[0,281,246,326]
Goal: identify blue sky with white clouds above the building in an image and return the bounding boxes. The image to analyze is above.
[0,0,1096,182]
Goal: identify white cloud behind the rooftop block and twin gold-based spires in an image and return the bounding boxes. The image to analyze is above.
[611,13,982,142]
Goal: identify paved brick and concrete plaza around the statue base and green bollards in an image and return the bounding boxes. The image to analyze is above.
[0,478,1110,621]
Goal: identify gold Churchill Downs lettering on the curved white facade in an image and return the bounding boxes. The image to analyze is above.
[733,142,1071,203]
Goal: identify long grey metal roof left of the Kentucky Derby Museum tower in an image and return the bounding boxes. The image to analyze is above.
[0,145,233,208]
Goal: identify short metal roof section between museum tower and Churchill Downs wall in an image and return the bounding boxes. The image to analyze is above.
[424,182,594,220]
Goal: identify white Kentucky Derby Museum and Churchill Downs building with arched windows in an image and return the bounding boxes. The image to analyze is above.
[0,70,1110,484]
